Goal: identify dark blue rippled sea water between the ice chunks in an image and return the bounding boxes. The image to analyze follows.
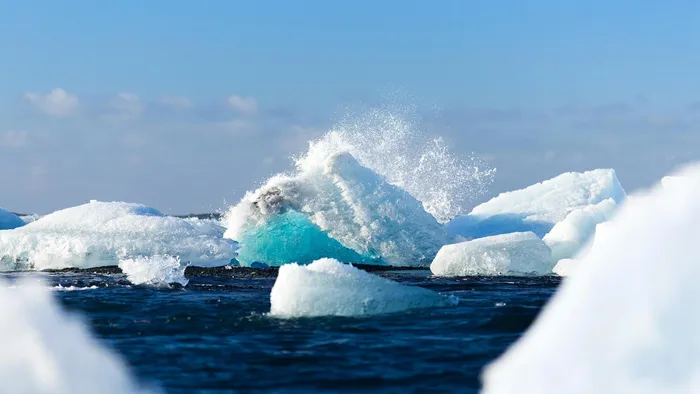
[12,270,559,393]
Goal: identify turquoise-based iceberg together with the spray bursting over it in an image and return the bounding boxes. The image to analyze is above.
[225,103,494,266]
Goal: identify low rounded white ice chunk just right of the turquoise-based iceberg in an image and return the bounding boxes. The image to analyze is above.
[430,232,554,276]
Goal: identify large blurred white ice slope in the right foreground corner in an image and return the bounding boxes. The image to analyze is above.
[483,166,700,394]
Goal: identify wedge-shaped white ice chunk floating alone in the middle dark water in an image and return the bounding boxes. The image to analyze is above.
[270,259,453,317]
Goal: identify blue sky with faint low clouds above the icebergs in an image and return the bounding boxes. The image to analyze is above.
[0,0,700,212]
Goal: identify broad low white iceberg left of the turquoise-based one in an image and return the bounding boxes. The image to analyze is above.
[0,202,237,270]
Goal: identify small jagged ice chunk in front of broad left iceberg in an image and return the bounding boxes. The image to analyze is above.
[119,256,188,287]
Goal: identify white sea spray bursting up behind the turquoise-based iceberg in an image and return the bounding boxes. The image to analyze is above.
[295,105,496,223]
